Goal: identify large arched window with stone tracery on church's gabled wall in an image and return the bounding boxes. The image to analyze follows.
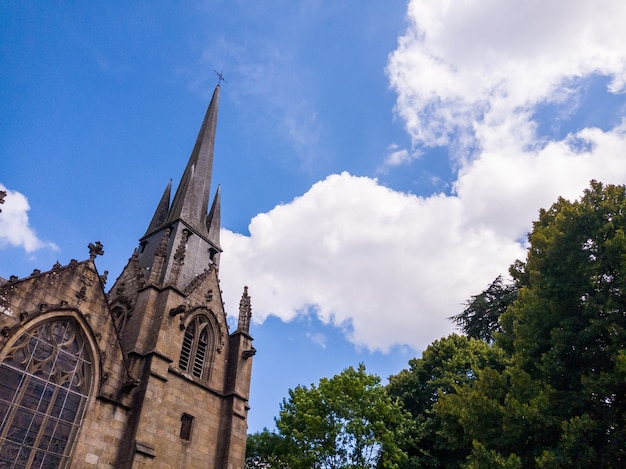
[0,318,92,469]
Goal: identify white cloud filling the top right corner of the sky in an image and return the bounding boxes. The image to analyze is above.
[388,0,626,150]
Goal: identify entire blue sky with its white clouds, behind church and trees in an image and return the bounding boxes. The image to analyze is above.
[0,0,626,431]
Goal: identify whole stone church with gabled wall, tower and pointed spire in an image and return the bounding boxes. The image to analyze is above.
[0,84,255,469]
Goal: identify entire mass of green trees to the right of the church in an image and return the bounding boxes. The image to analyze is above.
[250,181,626,469]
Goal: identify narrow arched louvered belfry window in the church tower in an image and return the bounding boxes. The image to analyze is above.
[178,315,211,379]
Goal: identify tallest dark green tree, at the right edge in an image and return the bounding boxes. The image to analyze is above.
[503,181,626,467]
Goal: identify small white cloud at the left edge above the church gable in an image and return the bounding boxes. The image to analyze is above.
[0,184,58,253]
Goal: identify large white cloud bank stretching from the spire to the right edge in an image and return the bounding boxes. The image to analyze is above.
[221,119,626,350]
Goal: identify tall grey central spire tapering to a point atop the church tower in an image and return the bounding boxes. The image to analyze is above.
[167,84,220,237]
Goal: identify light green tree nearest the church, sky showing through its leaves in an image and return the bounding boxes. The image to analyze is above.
[276,364,410,469]
